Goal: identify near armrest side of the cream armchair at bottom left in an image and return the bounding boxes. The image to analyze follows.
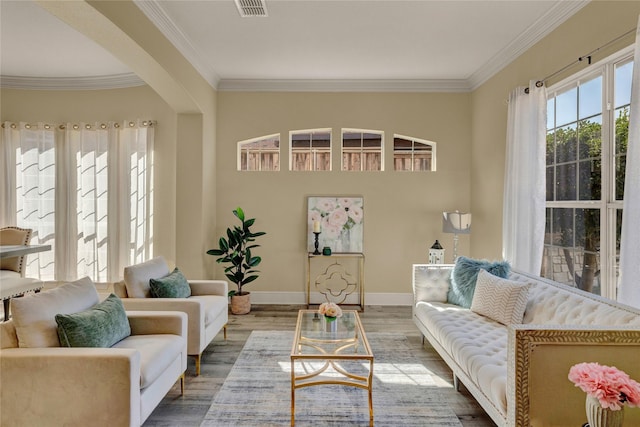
[0,347,140,426]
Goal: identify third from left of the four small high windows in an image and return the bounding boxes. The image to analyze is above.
[342,129,384,171]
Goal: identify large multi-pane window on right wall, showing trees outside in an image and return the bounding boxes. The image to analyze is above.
[542,46,633,298]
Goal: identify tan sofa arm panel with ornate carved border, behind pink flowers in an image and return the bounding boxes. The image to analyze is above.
[507,324,640,426]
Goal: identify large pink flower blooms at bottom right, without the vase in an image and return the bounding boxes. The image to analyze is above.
[569,363,640,411]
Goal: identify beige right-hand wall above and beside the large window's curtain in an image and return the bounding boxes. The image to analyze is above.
[471,1,640,258]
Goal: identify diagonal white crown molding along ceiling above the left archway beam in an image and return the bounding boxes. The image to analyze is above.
[134,0,220,89]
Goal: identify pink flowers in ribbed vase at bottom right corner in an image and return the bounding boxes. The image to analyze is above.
[569,363,640,427]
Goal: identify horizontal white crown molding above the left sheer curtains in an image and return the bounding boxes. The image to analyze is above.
[0,73,146,90]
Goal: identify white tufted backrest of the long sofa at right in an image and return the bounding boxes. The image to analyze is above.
[509,272,640,326]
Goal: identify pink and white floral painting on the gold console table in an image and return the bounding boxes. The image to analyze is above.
[307,197,364,253]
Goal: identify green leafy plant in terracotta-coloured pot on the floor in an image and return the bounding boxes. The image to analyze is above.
[207,208,266,314]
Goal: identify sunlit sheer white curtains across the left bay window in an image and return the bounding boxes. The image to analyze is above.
[0,121,154,282]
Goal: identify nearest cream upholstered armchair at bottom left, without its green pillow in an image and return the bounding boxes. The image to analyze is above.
[0,278,187,427]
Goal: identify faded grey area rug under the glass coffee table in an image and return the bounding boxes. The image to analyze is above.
[201,331,461,427]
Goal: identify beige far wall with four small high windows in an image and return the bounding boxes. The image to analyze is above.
[218,92,471,300]
